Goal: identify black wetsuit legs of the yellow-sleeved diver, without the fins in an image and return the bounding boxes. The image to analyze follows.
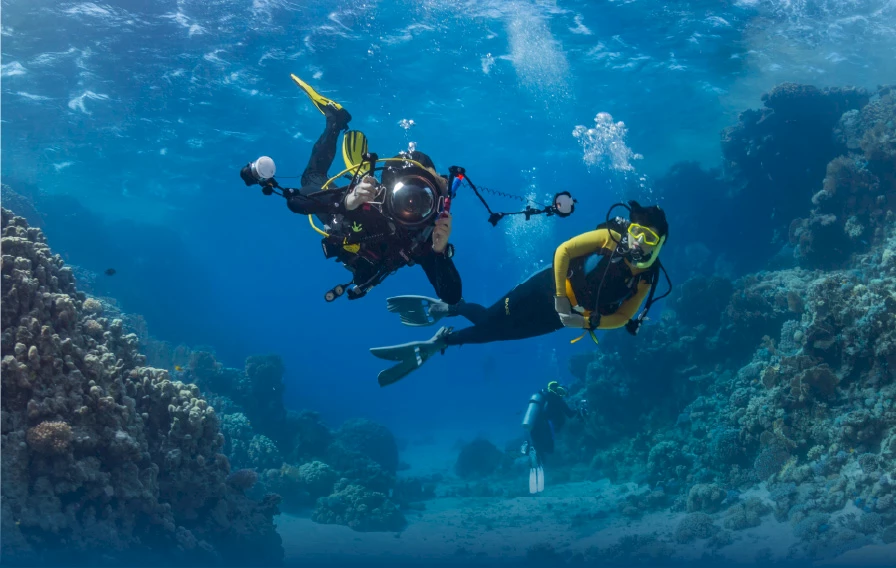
[443,266,563,345]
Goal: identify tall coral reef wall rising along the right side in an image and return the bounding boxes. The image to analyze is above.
[561,85,896,557]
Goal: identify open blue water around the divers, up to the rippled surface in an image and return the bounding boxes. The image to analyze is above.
[2,0,896,436]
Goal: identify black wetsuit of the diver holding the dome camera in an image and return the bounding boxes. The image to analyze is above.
[286,119,463,304]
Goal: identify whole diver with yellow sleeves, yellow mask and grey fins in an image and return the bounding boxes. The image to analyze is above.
[370,201,672,386]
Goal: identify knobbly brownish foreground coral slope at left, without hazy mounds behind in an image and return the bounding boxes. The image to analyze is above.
[0,209,282,564]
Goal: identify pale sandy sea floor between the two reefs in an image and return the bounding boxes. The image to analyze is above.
[276,428,896,566]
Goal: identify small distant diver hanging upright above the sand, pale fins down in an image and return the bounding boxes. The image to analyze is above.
[520,381,588,493]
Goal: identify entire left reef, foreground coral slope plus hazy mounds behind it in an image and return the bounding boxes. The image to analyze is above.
[2,201,412,540]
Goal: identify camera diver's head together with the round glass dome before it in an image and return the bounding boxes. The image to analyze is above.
[382,151,448,228]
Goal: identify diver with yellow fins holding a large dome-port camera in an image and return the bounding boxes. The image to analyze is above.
[240,79,462,304]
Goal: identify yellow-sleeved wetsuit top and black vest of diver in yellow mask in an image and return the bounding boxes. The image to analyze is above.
[554,229,650,329]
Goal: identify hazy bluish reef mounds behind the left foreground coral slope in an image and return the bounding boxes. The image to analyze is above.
[140,338,410,531]
